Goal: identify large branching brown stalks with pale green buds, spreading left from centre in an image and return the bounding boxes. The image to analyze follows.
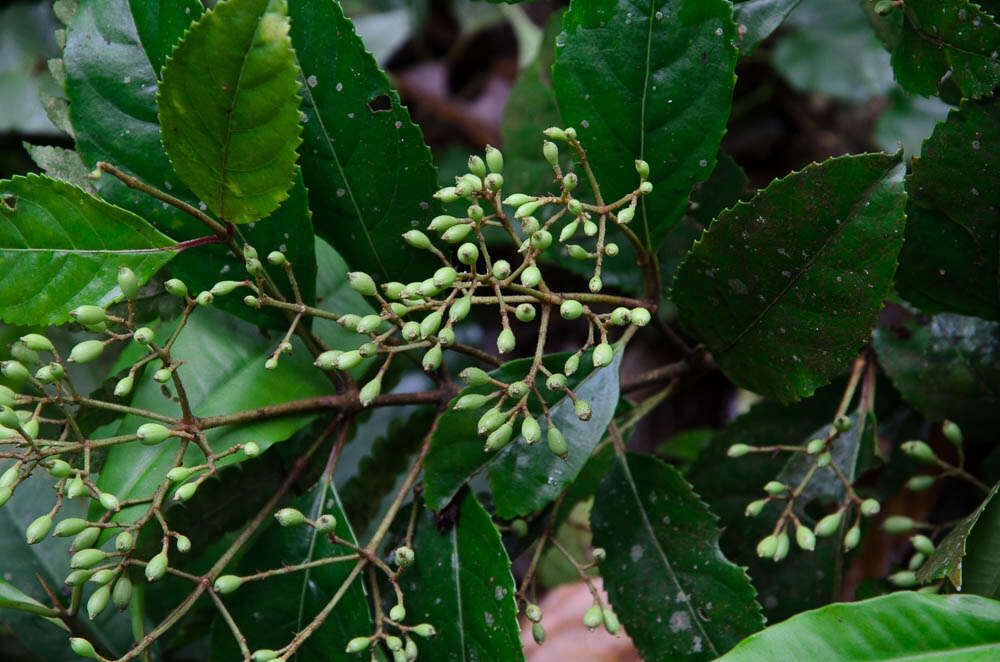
[0,128,658,662]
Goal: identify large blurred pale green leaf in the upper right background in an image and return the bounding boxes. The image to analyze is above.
[772,0,893,103]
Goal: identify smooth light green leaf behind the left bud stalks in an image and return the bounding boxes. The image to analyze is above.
[95,309,330,532]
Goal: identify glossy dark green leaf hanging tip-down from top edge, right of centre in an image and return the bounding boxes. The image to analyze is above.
[552,0,738,250]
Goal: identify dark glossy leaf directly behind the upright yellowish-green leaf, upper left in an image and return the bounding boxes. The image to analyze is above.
[64,0,315,329]
